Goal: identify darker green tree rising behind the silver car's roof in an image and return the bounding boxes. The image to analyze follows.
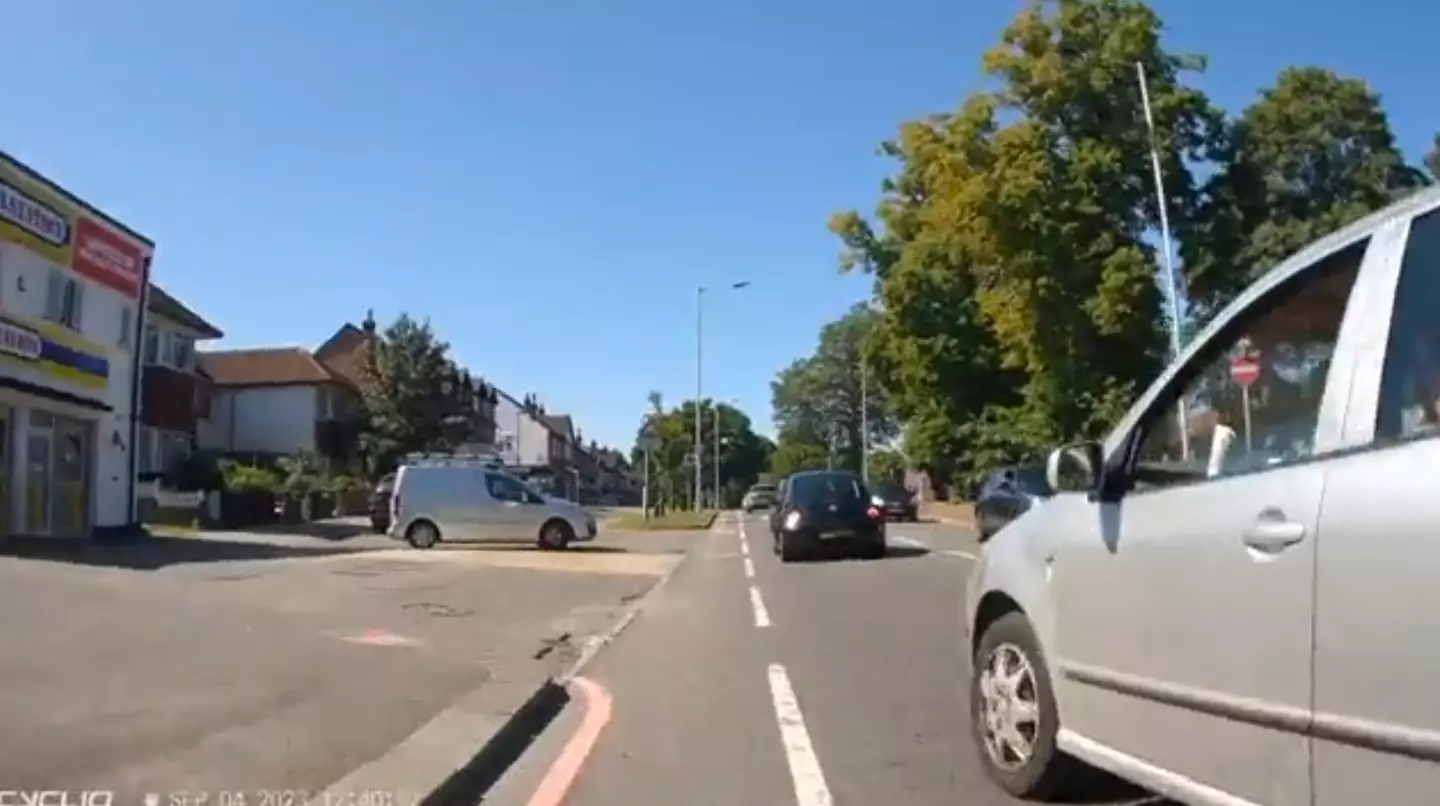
[1182,68,1436,312]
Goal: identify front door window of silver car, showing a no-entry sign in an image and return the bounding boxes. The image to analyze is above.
[1133,240,1368,489]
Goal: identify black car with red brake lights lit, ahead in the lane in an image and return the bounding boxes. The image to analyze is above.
[772,471,886,563]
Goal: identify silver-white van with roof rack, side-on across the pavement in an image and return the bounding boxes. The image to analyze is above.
[389,461,596,550]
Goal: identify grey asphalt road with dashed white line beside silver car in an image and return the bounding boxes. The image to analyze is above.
[518,515,1161,806]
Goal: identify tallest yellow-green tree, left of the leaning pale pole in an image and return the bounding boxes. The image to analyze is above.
[831,0,1225,482]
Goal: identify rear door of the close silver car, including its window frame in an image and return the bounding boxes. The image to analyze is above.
[1313,204,1440,806]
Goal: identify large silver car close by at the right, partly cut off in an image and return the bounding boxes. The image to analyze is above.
[966,190,1440,806]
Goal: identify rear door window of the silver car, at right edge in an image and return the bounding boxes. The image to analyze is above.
[1375,207,1440,443]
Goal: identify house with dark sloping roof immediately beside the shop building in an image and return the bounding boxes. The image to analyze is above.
[135,284,225,478]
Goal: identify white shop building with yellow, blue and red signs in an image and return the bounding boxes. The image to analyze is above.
[0,153,154,535]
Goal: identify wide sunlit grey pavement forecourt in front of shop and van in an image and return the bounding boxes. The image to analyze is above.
[0,518,696,803]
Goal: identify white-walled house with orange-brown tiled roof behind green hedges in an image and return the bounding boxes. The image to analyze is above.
[200,324,367,465]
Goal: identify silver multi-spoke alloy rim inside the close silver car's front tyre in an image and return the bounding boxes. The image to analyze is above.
[979,643,1041,771]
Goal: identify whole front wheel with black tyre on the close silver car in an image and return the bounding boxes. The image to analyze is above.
[971,612,1076,800]
